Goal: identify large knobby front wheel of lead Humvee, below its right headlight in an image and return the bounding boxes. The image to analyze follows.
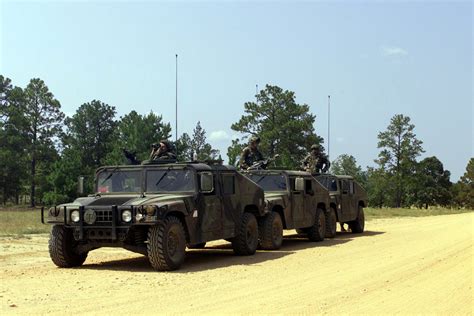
[147,216,186,271]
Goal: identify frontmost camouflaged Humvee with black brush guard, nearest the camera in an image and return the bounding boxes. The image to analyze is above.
[41,162,265,270]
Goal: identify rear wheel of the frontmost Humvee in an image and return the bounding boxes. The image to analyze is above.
[232,213,258,256]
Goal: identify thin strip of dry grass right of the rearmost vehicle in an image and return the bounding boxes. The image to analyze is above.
[364,207,473,220]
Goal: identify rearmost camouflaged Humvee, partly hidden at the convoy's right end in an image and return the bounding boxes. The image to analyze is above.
[314,173,367,233]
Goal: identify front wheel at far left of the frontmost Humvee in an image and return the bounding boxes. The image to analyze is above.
[48,225,87,268]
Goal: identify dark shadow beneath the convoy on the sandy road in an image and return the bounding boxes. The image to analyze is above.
[77,231,384,273]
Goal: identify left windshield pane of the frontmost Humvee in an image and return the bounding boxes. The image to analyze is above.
[97,168,142,193]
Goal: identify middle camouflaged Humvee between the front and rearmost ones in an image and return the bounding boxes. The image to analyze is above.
[244,170,335,250]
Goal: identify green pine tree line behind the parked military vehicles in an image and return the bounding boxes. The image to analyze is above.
[0,75,474,208]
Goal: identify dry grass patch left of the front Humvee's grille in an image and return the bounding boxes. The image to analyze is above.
[0,208,51,236]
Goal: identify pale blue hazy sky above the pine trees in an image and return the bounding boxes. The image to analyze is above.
[0,0,474,181]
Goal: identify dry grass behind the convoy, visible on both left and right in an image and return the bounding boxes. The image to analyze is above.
[0,207,473,237]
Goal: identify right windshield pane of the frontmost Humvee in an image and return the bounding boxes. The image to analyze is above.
[146,169,195,192]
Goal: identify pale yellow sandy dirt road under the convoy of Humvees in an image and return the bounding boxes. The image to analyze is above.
[0,213,474,315]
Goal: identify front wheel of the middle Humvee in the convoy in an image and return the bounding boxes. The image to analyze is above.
[258,212,283,250]
